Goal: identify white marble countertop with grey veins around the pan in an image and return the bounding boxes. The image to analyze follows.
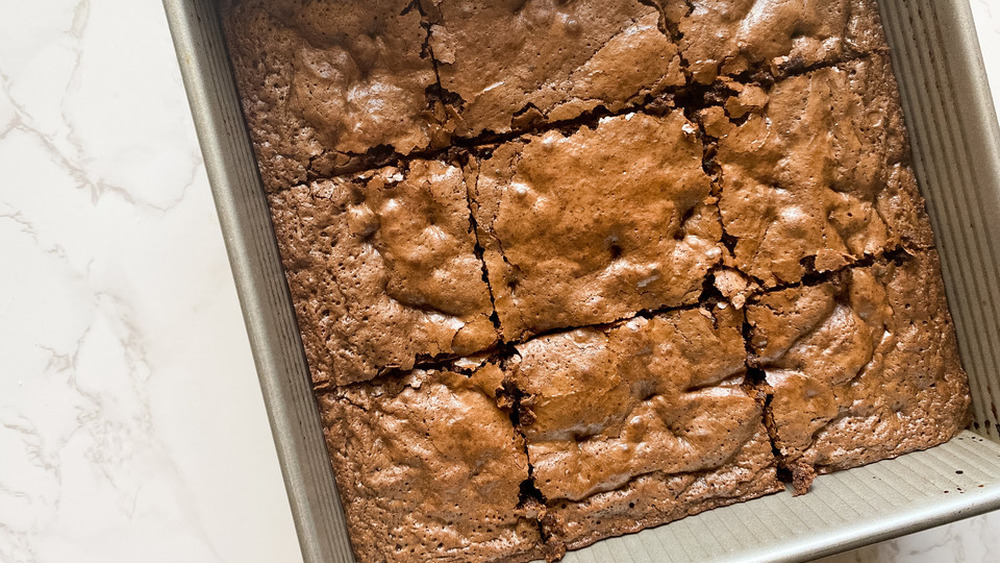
[0,0,1000,563]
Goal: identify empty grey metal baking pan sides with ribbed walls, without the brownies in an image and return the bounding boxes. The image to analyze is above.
[163,0,1000,563]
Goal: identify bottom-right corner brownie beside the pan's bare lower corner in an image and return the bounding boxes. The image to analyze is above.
[747,250,970,493]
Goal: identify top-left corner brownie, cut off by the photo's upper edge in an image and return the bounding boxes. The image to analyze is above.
[221,0,441,190]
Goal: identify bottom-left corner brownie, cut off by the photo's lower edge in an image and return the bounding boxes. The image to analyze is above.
[319,365,541,562]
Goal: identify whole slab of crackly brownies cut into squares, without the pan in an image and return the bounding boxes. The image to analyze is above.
[222,0,969,563]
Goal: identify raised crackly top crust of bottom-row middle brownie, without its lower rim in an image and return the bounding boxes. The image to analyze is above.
[509,307,761,500]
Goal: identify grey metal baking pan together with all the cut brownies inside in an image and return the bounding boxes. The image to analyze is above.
[164,0,1000,562]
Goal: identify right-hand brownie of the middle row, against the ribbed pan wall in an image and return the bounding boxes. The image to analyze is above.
[702,56,933,287]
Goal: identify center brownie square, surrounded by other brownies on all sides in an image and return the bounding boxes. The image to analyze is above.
[468,111,722,341]
